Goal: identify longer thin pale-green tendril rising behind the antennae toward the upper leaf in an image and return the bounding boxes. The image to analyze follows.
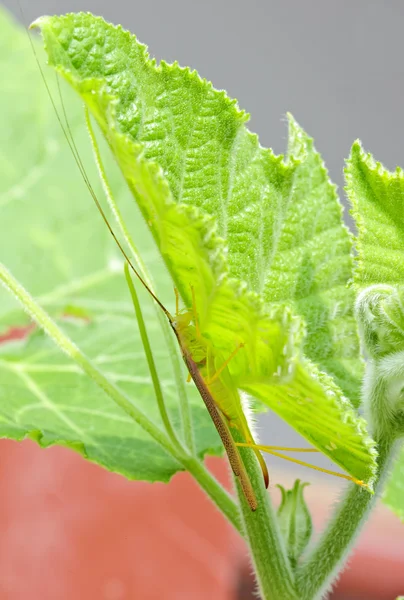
[84,107,195,454]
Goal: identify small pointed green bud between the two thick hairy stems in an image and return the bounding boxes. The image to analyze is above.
[278,479,313,567]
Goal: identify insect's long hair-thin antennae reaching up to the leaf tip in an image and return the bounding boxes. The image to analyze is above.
[20,16,173,324]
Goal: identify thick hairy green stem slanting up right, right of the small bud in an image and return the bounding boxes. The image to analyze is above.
[297,440,398,600]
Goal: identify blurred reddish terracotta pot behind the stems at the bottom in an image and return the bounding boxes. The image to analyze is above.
[0,440,404,600]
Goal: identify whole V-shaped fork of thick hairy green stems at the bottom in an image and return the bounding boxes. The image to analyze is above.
[232,376,402,600]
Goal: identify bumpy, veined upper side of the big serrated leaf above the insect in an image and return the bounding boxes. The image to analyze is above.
[38,14,362,403]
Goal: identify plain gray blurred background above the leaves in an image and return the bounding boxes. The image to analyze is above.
[3,0,404,477]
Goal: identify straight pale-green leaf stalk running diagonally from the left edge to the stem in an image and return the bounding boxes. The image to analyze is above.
[0,263,241,533]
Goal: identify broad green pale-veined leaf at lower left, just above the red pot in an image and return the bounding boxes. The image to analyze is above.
[0,310,220,481]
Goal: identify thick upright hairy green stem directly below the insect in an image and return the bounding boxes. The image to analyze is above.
[231,428,300,600]
